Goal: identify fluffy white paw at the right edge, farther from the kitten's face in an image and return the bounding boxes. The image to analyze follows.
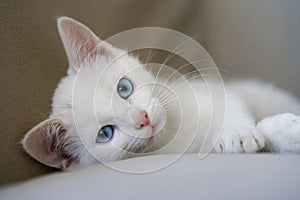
[257,113,300,153]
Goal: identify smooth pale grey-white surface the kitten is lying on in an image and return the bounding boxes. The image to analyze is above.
[0,154,300,200]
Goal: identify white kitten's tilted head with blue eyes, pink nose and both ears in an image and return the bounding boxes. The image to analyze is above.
[22,17,166,169]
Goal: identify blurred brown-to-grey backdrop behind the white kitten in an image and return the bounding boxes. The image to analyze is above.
[0,0,300,184]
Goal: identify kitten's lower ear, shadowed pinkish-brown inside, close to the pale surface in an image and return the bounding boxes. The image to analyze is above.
[22,119,78,169]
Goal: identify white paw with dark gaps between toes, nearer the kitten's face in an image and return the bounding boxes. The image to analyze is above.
[215,128,265,153]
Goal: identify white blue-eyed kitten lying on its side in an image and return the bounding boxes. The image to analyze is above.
[22,17,300,169]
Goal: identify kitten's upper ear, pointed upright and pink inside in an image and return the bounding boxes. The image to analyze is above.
[57,17,114,74]
